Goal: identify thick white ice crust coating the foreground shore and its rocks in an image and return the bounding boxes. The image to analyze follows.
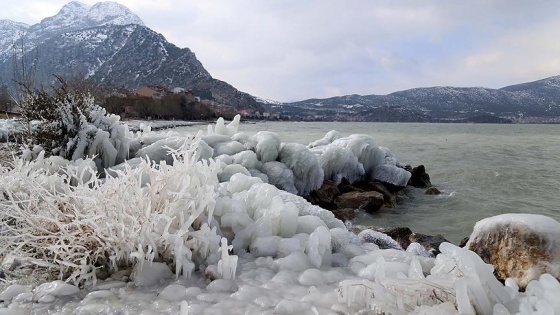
[0,120,560,314]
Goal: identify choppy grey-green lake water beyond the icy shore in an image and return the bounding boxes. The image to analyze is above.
[177,122,560,242]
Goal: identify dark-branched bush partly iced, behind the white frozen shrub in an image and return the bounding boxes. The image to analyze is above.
[21,80,130,169]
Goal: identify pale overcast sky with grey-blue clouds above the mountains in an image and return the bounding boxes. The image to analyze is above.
[0,0,560,101]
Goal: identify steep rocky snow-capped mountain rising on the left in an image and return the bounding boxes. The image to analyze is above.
[0,1,260,110]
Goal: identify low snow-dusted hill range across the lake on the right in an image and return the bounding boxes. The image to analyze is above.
[261,76,560,122]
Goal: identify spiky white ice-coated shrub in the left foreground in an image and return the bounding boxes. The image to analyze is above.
[0,138,220,283]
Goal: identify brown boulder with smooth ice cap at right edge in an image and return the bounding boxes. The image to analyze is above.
[466,214,560,288]
